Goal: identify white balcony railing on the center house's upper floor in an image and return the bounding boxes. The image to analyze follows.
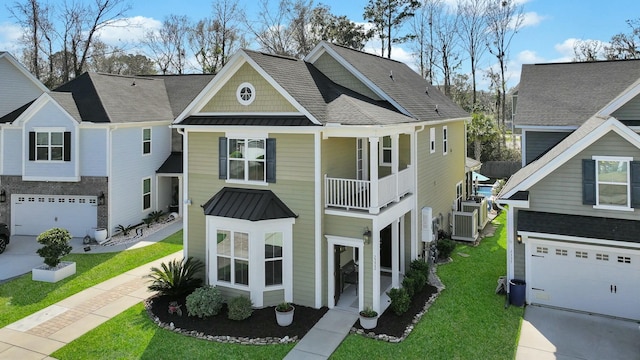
[324,166,414,214]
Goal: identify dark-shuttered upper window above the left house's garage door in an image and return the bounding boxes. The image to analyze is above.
[29,131,71,161]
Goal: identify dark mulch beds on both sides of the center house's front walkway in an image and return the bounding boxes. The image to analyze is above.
[148,285,437,342]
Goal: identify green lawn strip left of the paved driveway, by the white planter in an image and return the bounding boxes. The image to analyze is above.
[0,231,182,327]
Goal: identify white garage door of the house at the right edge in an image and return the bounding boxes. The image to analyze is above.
[527,239,640,320]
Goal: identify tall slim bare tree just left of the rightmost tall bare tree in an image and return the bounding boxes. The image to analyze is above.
[458,0,487,106]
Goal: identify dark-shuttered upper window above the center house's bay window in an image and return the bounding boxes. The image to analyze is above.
[219,137,276,183]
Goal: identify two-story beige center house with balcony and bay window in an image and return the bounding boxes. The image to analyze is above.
[174,42,477,311]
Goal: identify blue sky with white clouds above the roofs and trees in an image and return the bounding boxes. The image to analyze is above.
[0,0,640,86]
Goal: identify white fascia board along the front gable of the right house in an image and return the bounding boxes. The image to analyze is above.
[504,117,640,198]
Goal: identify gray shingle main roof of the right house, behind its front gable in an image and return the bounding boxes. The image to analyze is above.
[515,60,640,126]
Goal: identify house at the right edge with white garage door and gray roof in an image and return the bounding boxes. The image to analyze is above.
[498,61,640,320]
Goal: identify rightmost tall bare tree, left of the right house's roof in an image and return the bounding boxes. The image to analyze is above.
[487,0,524,143]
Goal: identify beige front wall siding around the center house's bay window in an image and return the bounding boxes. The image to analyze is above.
[186,133,315,306]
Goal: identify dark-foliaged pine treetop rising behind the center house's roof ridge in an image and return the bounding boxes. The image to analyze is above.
[363,0,420,58]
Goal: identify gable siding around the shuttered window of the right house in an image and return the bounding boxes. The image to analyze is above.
[529,132,640,220]
